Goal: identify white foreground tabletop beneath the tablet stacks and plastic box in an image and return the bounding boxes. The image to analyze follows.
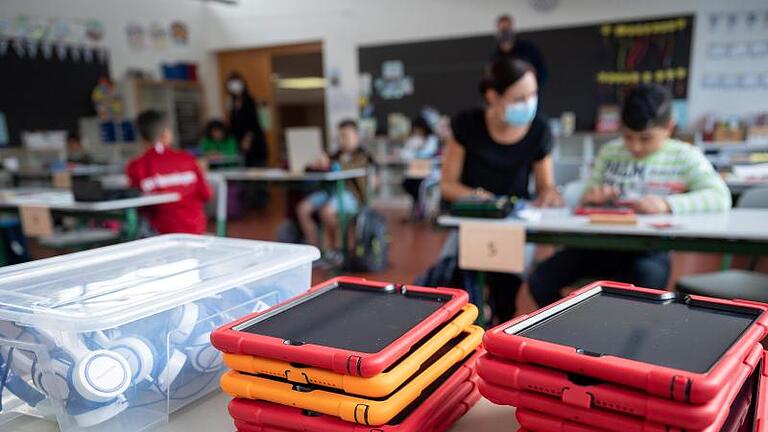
[2,393,517,432]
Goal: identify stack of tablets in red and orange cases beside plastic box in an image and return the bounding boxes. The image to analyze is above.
[211,277,483,432]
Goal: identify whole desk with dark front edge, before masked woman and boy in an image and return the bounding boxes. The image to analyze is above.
[438,208,768,320]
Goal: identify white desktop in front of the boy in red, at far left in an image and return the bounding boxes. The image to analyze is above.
[0,189,181,212]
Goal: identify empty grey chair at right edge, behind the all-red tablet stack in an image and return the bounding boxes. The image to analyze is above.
[675,187,768,303]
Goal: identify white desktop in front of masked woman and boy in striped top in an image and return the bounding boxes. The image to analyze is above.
[438,209,768,242]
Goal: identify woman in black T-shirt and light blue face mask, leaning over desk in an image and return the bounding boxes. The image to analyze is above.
[440,58,562,322]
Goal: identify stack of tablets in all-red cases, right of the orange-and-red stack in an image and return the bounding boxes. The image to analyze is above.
[477,282,768,432]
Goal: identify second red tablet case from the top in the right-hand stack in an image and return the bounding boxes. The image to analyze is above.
[477,345,762,429]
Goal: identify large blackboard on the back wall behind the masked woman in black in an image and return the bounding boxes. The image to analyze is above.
[358,15,694,132]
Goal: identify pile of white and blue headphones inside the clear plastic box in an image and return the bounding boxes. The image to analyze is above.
[0,303,223,427]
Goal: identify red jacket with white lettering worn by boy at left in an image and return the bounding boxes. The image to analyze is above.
[126,145,211,234]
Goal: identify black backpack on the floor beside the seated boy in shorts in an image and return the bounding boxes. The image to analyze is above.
[346,207,391,273]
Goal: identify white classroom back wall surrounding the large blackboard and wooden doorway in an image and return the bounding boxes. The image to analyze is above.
[0,0,768,140]
